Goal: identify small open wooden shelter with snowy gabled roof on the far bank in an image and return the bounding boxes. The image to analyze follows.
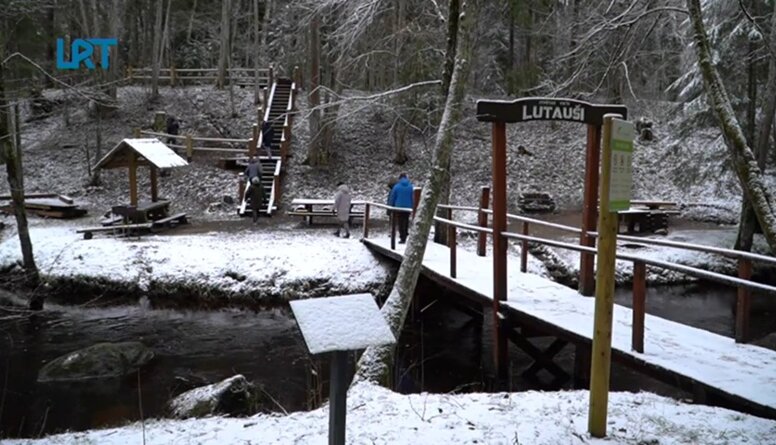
[96,138,189,206]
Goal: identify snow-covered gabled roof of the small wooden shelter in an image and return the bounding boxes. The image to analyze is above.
[97,138,189,168]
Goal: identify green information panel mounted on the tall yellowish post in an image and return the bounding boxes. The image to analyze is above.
[609,119,635,212]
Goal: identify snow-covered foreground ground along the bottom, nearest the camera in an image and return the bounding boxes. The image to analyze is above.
[4,383,776,445]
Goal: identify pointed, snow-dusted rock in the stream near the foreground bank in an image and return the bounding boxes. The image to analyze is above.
[170,374,257,419]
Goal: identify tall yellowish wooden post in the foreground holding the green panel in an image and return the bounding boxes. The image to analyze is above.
[588,115,617,437]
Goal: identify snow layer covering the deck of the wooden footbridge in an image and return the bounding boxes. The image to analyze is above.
[368,239,776,414]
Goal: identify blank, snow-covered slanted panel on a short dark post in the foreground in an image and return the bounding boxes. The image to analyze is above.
[290,294,396,354]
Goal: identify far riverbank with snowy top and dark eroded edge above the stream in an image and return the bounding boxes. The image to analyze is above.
[0,219,394,308]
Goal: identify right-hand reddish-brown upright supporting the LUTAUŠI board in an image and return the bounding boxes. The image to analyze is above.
[579,125,601,296]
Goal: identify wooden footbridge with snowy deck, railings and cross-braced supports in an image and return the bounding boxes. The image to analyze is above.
[362,202,776,419]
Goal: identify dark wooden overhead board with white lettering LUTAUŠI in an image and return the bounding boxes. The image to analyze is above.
[477,97,628,125]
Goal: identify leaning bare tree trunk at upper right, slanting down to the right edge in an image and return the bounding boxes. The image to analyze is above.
[687,0,776,254]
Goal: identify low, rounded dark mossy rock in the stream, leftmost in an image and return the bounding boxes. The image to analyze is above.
[38,341,154,383]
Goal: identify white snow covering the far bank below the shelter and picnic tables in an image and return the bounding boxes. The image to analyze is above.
[0,221,390,299]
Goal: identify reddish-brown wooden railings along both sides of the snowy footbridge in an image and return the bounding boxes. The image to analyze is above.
[363,203,776,353]
